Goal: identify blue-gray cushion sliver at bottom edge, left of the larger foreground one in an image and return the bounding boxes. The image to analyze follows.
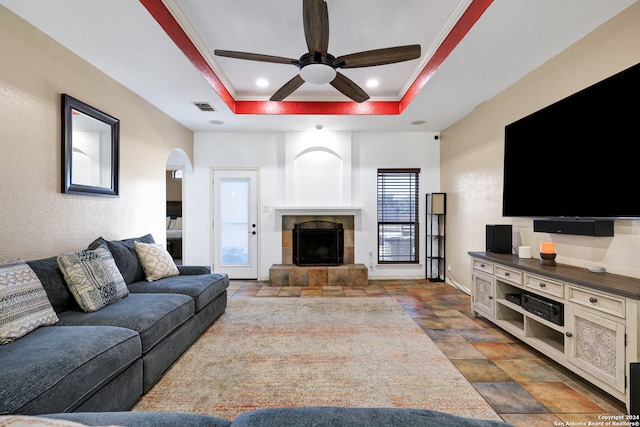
[43,412,231,427]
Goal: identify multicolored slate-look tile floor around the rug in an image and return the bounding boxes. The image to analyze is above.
[229,280,626,427]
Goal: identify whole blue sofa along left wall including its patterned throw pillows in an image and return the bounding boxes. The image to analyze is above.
[0,235,229,415]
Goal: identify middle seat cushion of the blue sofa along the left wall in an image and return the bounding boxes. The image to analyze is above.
[58,294,195,353]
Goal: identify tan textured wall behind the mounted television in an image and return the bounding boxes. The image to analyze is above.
[440,3,640,287]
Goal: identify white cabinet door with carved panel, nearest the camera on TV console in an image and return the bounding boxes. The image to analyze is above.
[565,304,625,392]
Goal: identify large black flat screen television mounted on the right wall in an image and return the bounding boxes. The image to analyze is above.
[502,64,640,219]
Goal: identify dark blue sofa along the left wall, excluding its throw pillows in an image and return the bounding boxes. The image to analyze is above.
[0,235,229,415]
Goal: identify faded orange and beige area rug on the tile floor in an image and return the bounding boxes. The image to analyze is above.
[133,298,500,420]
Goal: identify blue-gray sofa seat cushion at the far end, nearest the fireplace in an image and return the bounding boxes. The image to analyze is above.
[129,274,229,313]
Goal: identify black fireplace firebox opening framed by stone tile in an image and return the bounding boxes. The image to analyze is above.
[292,221,344,265]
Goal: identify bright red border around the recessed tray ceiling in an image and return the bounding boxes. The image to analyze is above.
[140,0,493,115]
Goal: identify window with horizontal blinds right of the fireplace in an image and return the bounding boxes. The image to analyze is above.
[378,169,420,264]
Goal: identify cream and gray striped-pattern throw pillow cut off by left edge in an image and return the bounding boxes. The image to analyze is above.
[0,259,58,344]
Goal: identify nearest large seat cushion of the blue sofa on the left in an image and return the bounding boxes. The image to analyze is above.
[0,326,142,415]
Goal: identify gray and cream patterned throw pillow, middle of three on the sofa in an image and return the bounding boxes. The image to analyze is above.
[58,245,129,312]
